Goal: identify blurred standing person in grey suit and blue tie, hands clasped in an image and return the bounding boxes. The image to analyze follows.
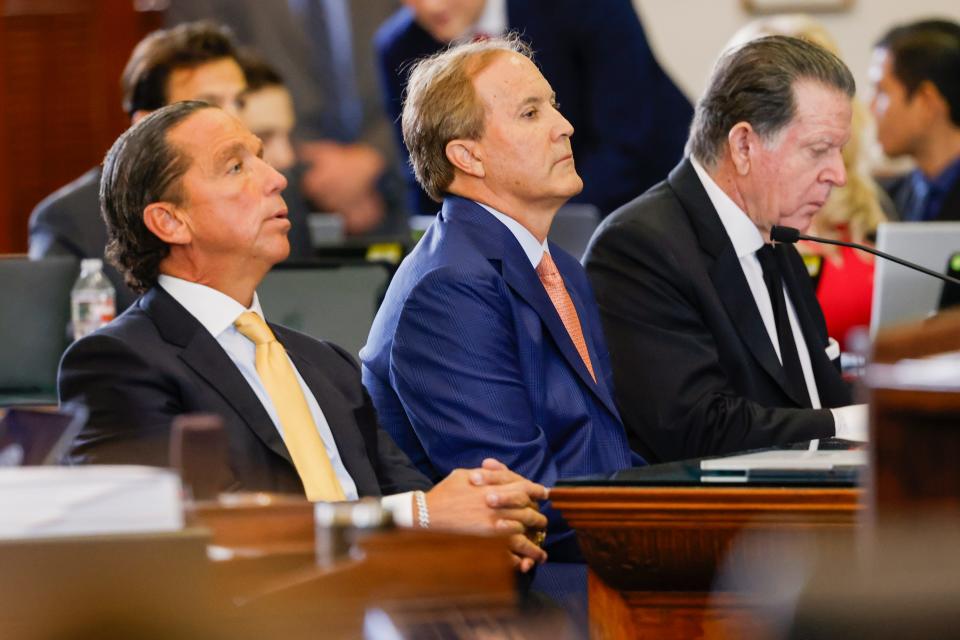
[167,0,407,235]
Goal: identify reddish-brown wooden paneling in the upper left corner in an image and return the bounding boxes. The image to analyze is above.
[0,0,160,253]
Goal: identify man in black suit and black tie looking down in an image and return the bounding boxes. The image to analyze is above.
[586,36,865,461]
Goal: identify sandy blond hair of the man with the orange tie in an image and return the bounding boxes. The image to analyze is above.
[401,34,533,202]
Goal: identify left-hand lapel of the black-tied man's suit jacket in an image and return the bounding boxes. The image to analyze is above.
[668,159,809,406]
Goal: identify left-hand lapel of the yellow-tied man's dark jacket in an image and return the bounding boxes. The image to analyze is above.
[141,287,293,464]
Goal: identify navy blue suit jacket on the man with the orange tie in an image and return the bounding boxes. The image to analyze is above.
[360,197,643,560]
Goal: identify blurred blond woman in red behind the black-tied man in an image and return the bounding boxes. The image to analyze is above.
[728,14,893,350]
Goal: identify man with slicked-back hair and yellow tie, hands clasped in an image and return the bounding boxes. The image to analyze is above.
[59,102,546,568]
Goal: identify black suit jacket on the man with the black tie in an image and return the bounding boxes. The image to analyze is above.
[585,160,851,461]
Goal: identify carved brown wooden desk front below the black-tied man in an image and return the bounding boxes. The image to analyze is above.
[550,468,862,639]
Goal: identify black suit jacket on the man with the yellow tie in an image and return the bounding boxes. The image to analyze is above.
[58,287,430,496]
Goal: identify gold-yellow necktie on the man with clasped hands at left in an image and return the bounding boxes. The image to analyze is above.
[234,311,346,502]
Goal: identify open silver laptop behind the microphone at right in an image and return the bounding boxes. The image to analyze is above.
[870,222,960,335]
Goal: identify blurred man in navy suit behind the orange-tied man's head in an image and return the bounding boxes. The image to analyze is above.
[374,0,693,215]
